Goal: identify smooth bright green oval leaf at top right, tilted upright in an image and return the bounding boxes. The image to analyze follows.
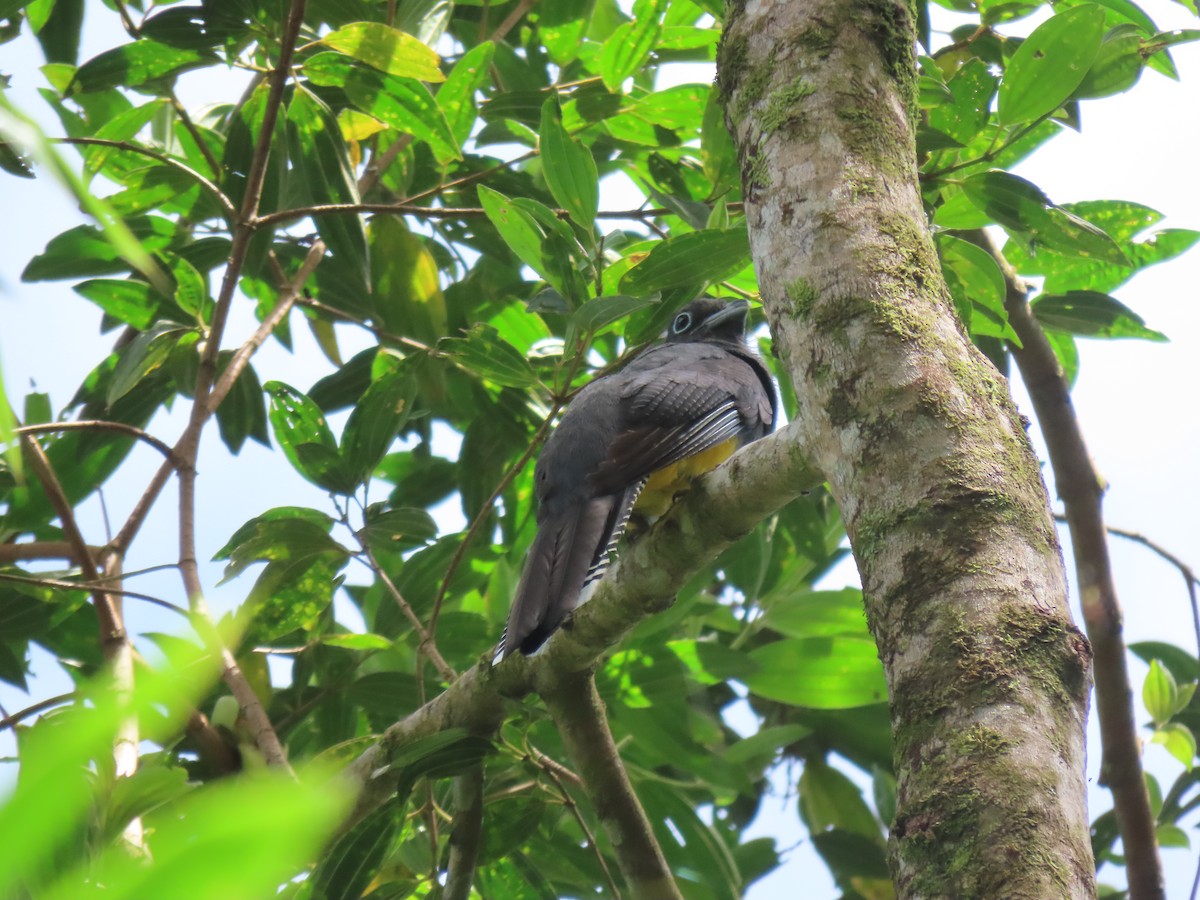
[998,4,1104,125]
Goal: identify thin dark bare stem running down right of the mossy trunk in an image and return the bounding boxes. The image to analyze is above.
[966,229,1165,900]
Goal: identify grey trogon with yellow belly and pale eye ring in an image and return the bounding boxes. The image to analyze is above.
[496,298,776,662]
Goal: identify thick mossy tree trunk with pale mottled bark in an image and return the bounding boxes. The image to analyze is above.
[718,0,1094,899]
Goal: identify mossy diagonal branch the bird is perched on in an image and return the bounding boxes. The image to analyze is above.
[346,424,824,823]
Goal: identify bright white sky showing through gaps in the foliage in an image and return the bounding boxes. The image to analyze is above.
[0,0,1200,900]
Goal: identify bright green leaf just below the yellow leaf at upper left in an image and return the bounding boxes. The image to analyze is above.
[304,53,462,163]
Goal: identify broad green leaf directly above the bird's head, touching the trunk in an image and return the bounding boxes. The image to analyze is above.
[620,228,750,295]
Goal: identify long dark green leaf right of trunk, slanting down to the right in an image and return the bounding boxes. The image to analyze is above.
[962,170,1129,265]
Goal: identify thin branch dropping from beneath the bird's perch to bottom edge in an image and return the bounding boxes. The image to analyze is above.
[542,672,683,900]
